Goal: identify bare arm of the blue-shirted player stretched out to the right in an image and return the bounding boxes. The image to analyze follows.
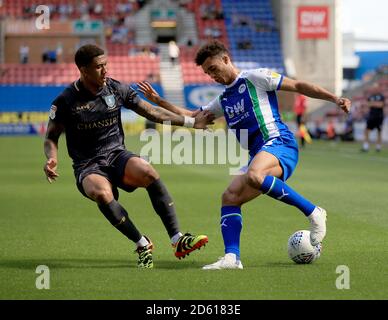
[280,77,352,113]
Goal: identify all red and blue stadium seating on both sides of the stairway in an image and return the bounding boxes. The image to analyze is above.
[0,0,284,107]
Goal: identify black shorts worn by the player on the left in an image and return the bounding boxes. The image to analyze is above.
[74,150,139,200]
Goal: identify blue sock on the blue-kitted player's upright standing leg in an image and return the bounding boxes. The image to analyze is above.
[221,206,242,260]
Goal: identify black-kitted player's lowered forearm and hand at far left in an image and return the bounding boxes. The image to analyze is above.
[43,119,64,183]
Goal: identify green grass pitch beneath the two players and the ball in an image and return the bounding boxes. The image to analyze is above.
[0,137,388,300]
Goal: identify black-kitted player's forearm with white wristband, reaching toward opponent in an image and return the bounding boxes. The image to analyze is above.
[132,99,214,129]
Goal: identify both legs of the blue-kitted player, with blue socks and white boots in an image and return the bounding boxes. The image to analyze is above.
[203,151,326,270]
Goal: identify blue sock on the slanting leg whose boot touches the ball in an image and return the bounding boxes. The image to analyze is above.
[260,176,315,217]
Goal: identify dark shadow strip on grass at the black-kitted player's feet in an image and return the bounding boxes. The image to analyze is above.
[0,258,203,270]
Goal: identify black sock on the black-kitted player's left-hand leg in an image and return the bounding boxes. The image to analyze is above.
[98,200,142,243]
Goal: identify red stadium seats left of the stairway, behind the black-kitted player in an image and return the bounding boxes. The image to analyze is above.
[0,0,160,85]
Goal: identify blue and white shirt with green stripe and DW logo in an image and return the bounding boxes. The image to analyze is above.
[201,69,292,154]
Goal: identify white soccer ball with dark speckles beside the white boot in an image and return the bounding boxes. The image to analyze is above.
[288,230,322,264]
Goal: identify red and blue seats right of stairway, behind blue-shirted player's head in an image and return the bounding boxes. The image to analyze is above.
[180,0,285,84]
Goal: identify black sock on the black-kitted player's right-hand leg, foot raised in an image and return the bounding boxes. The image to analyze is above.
[147,179,179,238]
